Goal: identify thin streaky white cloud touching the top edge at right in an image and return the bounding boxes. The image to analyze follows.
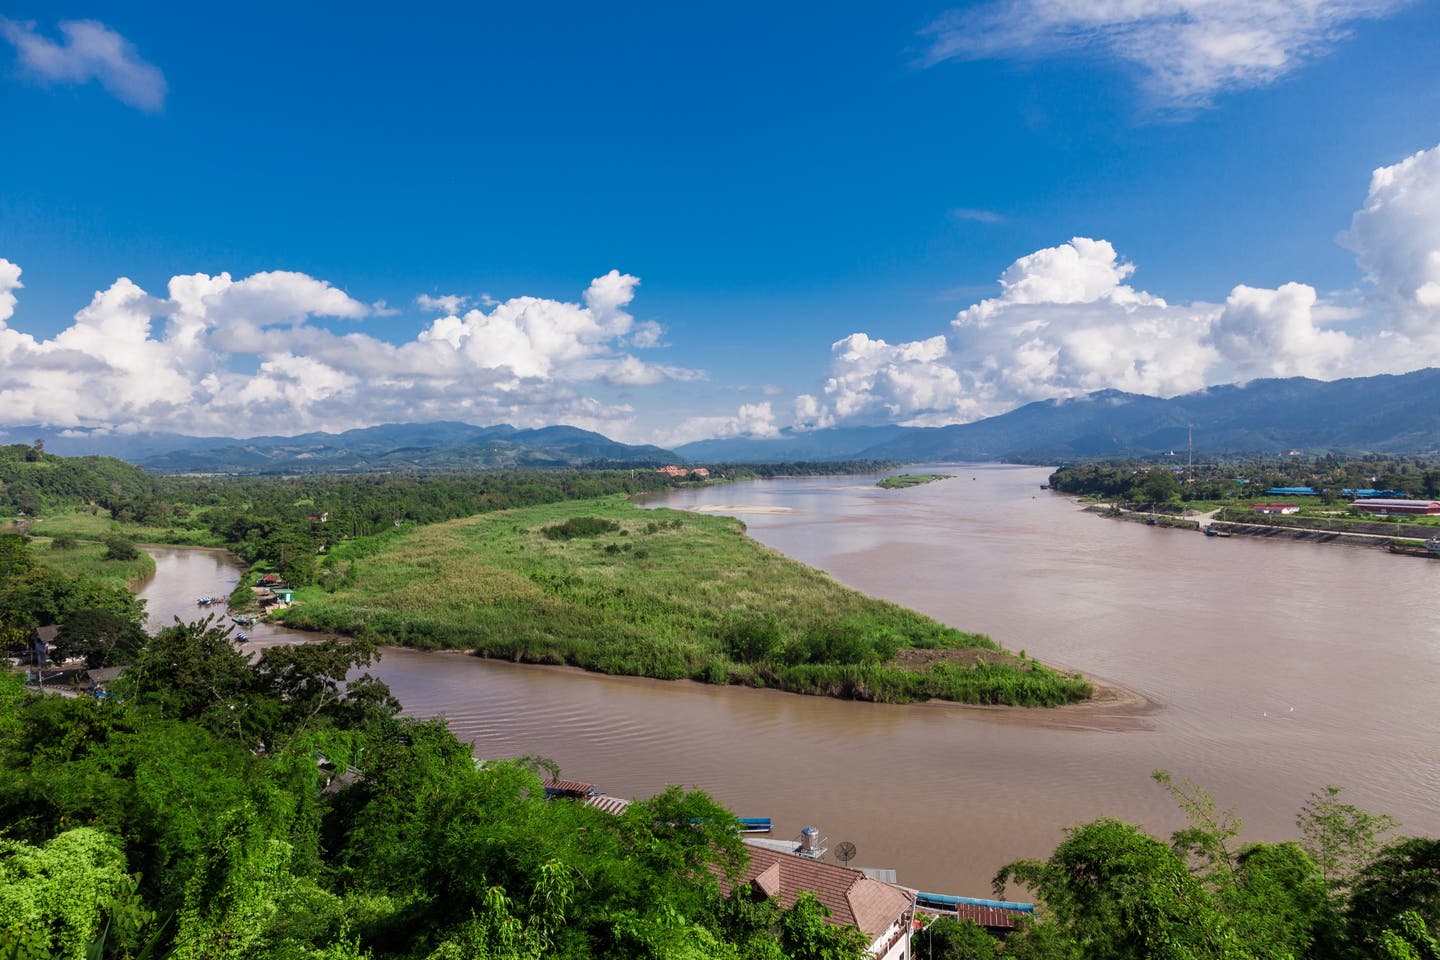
[926,0,1410,108]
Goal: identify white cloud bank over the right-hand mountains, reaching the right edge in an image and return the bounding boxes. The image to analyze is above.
[795,147,1440,427]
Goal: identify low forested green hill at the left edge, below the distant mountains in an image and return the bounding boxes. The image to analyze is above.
[0,443,156,517]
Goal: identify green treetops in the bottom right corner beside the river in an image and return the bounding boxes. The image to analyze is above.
[967,771,1440,960]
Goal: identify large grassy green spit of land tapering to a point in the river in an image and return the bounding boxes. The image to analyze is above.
[282,497,1093,707]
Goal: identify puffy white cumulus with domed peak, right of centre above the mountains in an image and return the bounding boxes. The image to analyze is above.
[796,237,1220,426]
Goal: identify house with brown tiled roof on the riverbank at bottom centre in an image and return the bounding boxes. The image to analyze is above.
[726,846,914,960]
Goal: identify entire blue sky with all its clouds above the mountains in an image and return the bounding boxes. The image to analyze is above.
[0,0,1440,443]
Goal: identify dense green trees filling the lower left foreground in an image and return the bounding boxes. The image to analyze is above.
[0,622,863,960]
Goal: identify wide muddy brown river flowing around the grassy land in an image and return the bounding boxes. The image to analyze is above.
[141,465,1440,897]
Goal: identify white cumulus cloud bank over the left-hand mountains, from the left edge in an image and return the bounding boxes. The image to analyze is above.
[0,266,700,435]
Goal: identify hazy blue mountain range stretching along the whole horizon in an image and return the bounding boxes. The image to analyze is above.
[11,367,1440,474]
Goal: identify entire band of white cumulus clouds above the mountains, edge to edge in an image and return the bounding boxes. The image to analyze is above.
[8,147,1440,443]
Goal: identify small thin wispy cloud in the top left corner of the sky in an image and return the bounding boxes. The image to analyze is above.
[0,17,166,112]
